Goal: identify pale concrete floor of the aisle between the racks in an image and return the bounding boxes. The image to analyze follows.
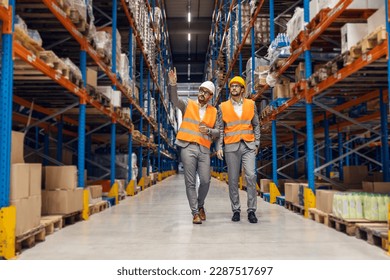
[18,175,390,260]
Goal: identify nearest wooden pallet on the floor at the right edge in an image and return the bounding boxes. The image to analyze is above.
[355,223,389,251]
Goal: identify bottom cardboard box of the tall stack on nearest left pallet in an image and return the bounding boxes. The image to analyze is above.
[10,195,41,236]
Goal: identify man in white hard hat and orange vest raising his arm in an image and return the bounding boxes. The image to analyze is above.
[168,66,219,224]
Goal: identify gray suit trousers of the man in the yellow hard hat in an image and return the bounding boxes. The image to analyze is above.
[225,142,257,212]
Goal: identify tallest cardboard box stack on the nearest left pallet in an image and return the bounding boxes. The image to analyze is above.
[10,131,42,236]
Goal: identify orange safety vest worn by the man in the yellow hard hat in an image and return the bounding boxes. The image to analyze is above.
[221,98,255,144]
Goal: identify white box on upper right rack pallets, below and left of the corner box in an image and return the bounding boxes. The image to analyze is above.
[341,23,368,53]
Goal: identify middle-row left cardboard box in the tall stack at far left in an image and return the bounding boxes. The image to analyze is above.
[10,163,30,200]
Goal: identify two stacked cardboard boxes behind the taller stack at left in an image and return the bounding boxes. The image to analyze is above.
[42,165,83,215]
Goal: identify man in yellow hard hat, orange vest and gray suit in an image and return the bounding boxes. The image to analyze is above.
[217,76,260,223]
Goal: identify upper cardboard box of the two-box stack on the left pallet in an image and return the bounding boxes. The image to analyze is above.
[45,165,77,190]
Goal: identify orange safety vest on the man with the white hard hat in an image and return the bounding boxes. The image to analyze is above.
[176,100,217,149]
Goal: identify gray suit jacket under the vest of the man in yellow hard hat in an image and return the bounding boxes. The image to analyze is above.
[216,99,260,152]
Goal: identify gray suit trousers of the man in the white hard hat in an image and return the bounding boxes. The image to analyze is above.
[180,144,211,215]
